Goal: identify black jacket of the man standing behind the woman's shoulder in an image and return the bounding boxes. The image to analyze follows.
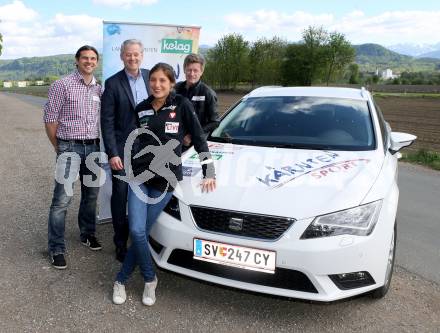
[175,81,219,133]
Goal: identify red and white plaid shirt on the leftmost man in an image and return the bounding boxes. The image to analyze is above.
[44,71,102,140]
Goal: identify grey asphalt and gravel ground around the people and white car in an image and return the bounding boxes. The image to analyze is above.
[0,93,440,332]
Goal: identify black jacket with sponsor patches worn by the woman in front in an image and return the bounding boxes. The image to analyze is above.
[131,94,215,191]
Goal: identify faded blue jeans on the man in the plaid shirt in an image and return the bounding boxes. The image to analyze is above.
[48,140,99,255]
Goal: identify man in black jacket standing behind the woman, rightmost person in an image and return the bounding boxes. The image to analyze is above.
[175,53,219,146]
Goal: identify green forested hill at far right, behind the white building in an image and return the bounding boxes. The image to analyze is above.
[353,44,440,72]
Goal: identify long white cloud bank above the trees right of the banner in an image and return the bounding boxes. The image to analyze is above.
[224,10,440,45]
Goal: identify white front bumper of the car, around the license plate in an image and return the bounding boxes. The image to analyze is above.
[150,196,397,302]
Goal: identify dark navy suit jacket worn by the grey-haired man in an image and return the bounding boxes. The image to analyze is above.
[101,69,150,159]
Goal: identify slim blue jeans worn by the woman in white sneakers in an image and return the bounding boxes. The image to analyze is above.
[116,184,172,284]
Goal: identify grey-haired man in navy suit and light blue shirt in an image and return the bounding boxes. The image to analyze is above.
[101,39,149,262]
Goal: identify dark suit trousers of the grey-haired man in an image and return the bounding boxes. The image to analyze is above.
[110,170,128,249]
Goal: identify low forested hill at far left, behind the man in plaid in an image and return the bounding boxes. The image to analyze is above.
[0,54,102,80]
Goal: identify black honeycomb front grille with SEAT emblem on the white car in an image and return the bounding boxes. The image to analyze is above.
[191,206,295,240]
